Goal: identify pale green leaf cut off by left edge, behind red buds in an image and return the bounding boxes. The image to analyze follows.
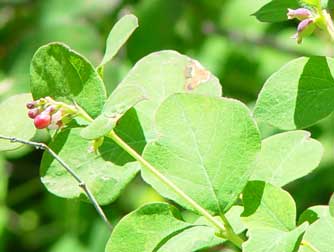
[0,94,36,151]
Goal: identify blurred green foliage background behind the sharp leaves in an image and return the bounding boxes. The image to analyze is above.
[0,0,334,252]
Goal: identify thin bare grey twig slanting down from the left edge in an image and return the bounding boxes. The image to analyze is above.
[0,135,112,230]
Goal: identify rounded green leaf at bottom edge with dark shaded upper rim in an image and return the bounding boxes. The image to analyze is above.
[105,203,193,252]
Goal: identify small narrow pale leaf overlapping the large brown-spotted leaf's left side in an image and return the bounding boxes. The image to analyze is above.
[81,86,145,139]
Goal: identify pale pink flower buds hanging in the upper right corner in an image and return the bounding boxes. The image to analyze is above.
[287,8,317,44]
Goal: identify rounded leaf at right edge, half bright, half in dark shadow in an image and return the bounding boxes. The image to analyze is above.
[255,57,334,130]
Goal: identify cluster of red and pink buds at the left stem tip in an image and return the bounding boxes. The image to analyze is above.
[26,97,68,129]
